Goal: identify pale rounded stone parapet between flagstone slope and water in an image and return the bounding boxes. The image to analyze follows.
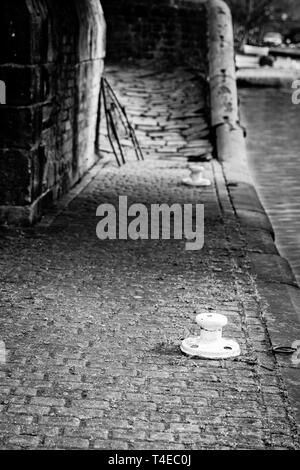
[206,0,274,236]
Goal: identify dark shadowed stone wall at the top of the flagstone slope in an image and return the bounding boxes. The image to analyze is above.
[101,0,206,67]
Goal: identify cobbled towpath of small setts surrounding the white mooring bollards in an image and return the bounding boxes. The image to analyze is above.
[0,64,298,450]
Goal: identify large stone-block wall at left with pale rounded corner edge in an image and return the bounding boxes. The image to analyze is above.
[0,0,105,223]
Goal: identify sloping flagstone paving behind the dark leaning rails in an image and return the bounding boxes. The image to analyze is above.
[100,66,212,161]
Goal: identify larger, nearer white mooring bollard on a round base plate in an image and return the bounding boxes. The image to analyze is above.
[181,313,241,359]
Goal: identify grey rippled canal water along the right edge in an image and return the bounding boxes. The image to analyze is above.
[239,88,300,283]
